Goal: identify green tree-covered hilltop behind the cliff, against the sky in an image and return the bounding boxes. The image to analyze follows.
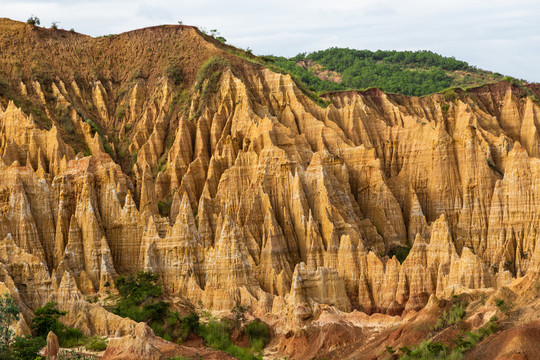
[263,48,502,96]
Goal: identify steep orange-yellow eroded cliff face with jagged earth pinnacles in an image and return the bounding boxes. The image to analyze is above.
[0,20,540,360]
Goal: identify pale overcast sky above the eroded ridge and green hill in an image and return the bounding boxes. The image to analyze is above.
[0,0,540,82]
